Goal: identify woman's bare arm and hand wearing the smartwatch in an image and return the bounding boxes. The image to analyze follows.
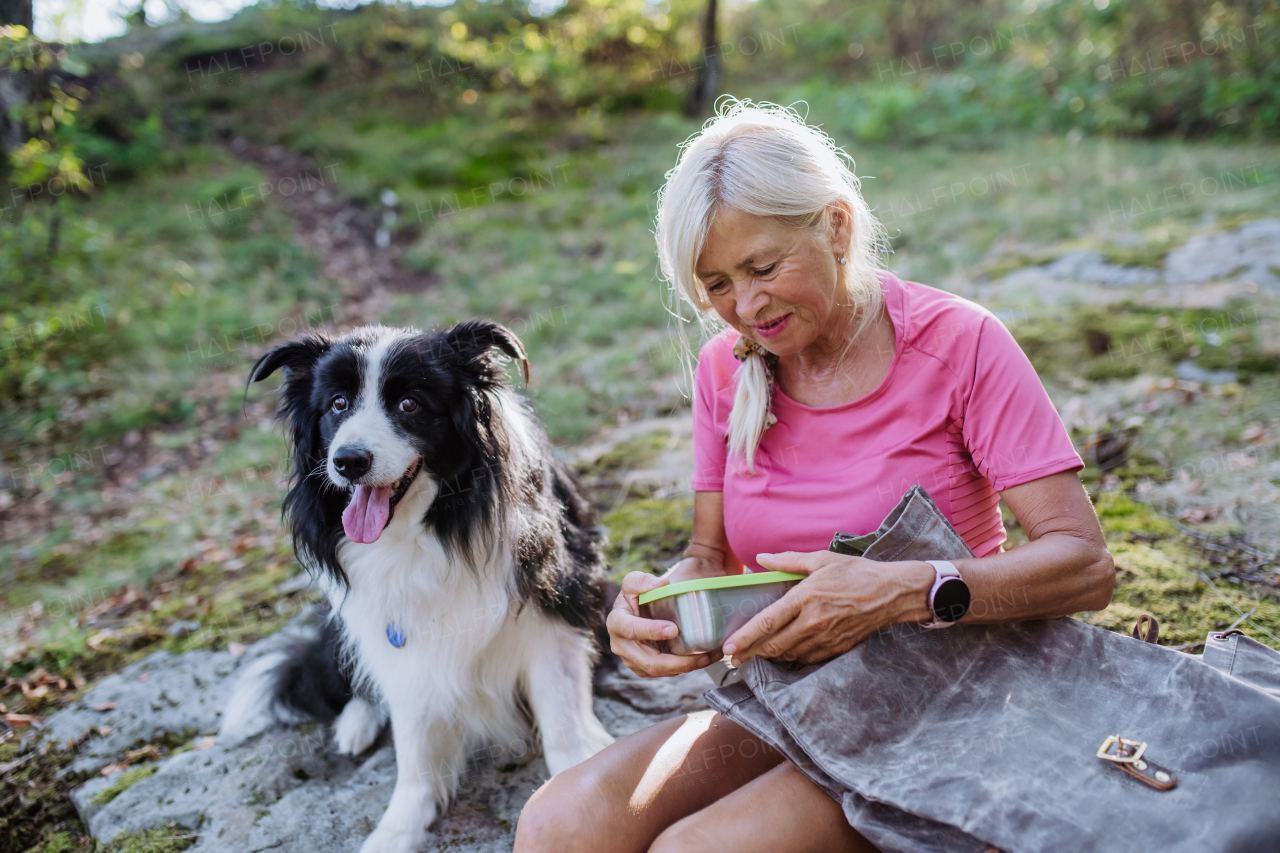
[724,471,1115,666]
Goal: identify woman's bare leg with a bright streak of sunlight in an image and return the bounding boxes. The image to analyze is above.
[515,711,783,853]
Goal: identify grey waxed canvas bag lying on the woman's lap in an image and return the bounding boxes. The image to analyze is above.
[704,487,1280,853]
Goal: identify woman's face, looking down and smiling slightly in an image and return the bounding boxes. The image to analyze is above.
[695,207,850,356]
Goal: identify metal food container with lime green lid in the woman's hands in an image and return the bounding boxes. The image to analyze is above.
[640,571,805,654]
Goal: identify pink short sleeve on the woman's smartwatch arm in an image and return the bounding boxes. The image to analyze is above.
[963,315,1084,492]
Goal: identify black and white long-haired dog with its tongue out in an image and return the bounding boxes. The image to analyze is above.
[220,320,613,853]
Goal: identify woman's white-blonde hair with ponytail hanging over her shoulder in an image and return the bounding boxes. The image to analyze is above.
[657,99,887,471]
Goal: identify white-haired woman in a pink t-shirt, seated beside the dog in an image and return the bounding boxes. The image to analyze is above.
[516,102,1115,853]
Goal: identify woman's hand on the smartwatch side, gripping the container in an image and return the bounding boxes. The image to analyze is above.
[723,551,934,666]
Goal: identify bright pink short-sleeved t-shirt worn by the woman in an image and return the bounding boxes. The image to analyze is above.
[692,273,1084,571]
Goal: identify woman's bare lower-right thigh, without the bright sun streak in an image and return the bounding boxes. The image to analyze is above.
[649,762,876,853]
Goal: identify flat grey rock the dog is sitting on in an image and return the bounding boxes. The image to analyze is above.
[46,610,713,853]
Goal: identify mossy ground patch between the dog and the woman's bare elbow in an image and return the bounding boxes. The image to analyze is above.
[604,498,694,581]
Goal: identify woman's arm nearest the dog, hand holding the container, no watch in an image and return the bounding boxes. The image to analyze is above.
[604,492,742,678]
